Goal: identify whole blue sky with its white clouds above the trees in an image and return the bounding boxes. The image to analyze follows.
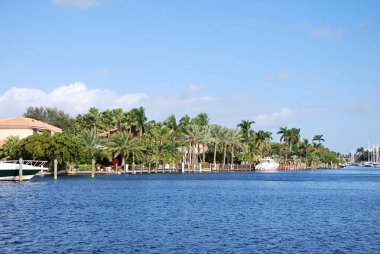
[0,0,380,153]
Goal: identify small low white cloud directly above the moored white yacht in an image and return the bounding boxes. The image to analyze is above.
[253,107,298,128]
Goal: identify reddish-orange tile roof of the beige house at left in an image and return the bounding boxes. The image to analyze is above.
[0,117,62,133]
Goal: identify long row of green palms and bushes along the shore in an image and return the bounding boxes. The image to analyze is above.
[0,107,338,167]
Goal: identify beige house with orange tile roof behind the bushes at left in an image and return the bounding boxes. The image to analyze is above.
[0,117,62,147]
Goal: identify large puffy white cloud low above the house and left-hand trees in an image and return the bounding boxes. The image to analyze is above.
[0,82,246,123]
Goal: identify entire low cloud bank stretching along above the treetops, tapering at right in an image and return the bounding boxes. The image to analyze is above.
[0,82,328,128]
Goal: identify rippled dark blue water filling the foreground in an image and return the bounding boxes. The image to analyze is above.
[0,168,380,253]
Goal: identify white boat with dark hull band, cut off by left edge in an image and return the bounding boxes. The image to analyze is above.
[0,160,48,181]
